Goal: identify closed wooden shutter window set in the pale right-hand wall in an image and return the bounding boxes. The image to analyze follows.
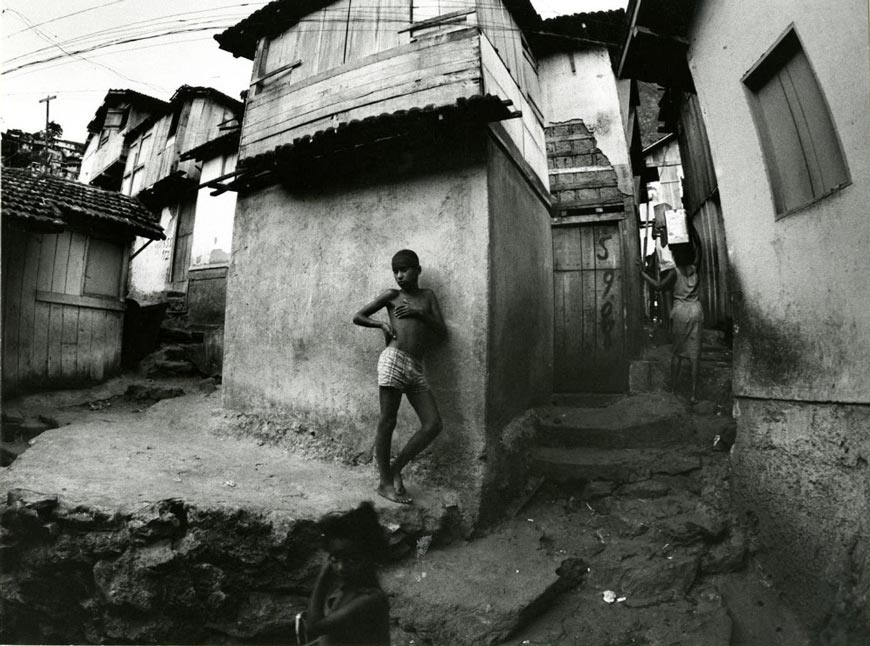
[743,29,850,216]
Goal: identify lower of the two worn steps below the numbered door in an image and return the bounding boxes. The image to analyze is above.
[529,446,701,483]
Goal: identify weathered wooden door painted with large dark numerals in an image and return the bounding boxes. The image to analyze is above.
[552,222,628,392]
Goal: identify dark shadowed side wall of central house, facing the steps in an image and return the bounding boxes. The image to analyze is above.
[485,141,553,513]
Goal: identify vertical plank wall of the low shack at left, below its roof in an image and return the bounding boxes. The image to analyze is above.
[3,229,126,393]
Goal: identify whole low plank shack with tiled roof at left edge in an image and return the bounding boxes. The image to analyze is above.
[2,168,163,395]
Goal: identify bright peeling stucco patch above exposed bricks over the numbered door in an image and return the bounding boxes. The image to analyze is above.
[538,47,634,195]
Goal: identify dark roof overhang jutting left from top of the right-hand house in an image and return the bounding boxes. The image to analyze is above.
[617,0,695,92]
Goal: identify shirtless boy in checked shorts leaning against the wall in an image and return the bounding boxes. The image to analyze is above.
[353,249,447,505]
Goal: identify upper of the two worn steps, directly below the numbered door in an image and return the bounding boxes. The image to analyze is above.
[536,393,692,448]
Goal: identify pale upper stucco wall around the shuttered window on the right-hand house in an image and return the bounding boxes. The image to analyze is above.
[689,0,870,403]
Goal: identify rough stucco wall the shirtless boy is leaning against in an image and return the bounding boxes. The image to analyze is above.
[223,158,489,516]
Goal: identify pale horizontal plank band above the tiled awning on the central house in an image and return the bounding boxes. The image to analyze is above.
[239,29,481,158]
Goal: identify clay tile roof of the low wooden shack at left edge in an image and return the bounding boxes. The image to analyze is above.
[0,168,165,240]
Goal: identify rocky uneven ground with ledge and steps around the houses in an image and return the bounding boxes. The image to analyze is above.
[0,342,809,646]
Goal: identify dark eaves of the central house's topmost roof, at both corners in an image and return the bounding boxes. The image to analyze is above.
[214,0,541,60]
